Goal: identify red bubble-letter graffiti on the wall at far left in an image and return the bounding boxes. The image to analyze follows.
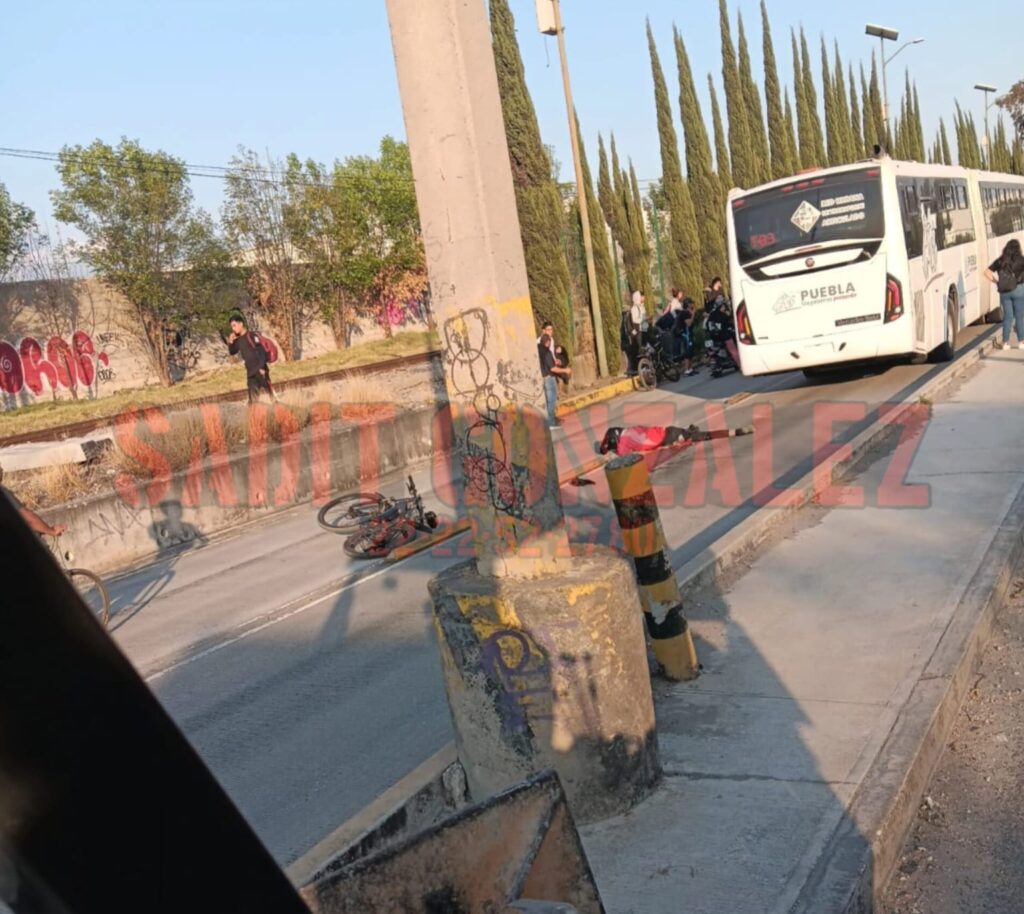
[0,330,114,396]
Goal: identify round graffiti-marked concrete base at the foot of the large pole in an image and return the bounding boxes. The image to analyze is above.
[430,548,660,822]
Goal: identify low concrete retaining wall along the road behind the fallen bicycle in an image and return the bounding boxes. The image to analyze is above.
[46,406,451,574]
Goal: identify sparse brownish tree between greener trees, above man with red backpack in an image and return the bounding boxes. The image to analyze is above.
[221,147,309,359]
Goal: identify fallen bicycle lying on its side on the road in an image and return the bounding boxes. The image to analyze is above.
[316,476,437,559]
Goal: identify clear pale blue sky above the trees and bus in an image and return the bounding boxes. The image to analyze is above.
[0,0,1024,228]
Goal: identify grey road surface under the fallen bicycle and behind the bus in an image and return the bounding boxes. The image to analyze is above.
[110,328,986,865]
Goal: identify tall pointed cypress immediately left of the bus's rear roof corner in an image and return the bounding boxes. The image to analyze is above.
[673,29,725,282]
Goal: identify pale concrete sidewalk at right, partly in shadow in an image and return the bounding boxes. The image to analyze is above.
[582,351,1024,914]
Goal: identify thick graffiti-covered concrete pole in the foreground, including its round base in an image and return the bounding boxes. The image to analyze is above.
[387,0,658,822]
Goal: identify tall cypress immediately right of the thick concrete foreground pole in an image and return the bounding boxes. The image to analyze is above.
[490,0,573,348]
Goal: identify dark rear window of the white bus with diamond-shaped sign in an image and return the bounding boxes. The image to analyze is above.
[732,169,885,266]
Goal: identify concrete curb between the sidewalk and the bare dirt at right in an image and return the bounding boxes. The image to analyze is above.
[790,470,1024,914]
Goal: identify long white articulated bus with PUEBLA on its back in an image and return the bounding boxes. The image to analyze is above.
[726,157,1024,376]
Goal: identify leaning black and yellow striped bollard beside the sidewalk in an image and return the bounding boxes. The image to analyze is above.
[604,453,700,681]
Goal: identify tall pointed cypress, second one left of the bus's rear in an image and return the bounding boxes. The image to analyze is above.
[647,21,702,290]
